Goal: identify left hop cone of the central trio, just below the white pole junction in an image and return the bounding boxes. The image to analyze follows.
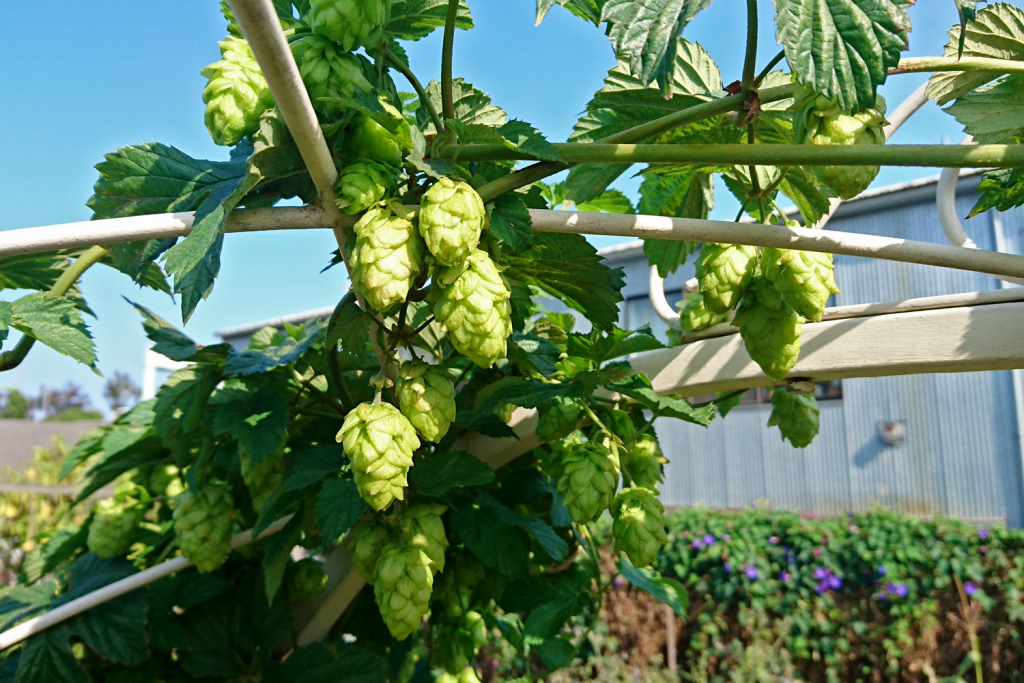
[349,203,423,312]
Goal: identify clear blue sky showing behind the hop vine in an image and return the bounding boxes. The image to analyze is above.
[0,0,974,408]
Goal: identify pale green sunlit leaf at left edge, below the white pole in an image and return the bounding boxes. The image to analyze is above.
[5,293,96,371]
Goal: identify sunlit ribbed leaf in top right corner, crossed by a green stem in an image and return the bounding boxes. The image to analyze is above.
[927,2,1024,104]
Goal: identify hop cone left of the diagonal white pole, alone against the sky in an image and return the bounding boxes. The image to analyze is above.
[201,37,273,146]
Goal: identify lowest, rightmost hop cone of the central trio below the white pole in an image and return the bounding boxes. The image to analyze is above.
[434,249,512,368]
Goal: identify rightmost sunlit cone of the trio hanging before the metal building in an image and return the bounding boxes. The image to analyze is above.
[763,242,839,323]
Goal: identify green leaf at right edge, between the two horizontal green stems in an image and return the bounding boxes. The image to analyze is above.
[946,76,1024,144]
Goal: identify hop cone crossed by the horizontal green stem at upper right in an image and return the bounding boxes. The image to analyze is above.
[804,95,888,200]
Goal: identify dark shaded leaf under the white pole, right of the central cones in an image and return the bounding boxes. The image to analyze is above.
[505,232,625,330]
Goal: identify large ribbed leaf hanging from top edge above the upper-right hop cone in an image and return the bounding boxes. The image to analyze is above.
[775,0,913,112]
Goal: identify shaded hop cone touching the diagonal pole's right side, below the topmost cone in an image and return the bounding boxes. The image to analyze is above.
[292,36,374,114]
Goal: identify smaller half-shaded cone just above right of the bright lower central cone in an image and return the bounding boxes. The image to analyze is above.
[398,360,456,443]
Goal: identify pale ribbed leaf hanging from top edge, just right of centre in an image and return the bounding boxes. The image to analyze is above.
[601,0,711,97]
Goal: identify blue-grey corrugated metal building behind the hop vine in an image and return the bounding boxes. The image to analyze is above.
[205,174,1024,526]
